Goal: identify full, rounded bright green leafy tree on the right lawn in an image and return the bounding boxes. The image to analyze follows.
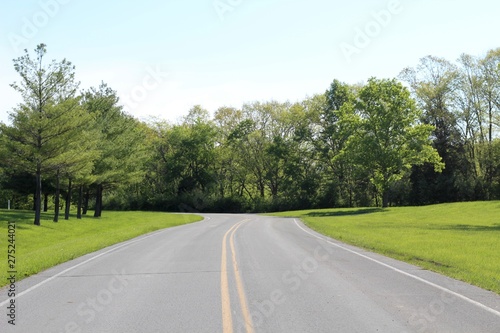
[346,78,444,207]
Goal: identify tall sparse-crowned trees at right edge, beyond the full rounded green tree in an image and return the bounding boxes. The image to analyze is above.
[401,50,500,204]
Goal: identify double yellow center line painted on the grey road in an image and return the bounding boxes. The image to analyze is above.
[220,219,254,333]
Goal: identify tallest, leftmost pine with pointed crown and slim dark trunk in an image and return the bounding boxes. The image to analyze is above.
[2,44,83,225]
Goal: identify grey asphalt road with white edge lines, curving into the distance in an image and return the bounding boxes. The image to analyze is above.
[0,214,500,333]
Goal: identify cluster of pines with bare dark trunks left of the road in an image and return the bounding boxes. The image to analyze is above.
[0,44,147,225]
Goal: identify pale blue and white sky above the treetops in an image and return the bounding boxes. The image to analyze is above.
[0,0,500,123]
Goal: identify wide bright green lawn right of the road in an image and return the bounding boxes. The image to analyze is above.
[271,201,500,294]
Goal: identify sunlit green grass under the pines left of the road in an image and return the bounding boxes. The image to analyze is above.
[0,210,202,287]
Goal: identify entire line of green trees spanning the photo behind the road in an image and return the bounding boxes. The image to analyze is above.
[0,44,500,224]
